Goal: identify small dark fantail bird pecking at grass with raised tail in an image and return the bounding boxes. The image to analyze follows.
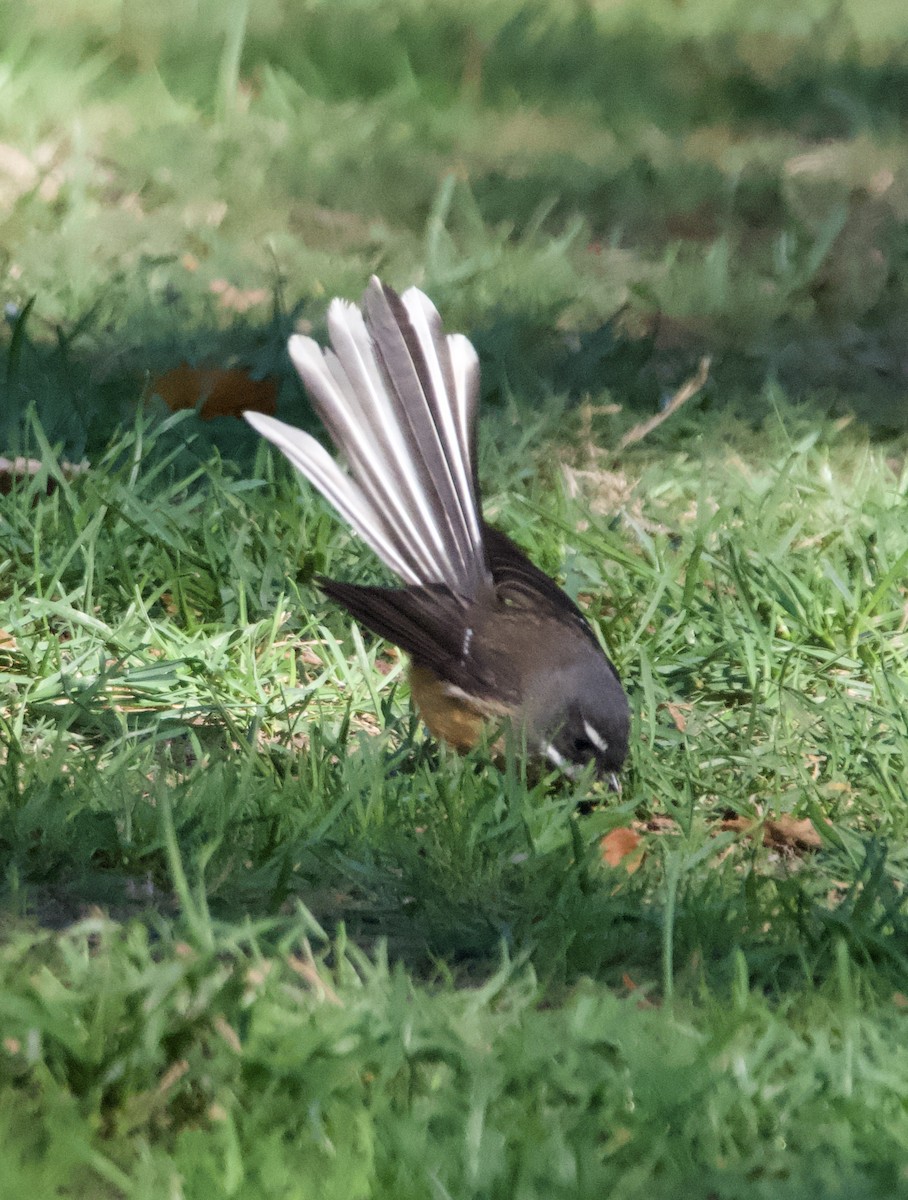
[243,276,630,790]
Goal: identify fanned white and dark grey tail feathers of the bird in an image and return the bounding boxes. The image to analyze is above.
[243,277,489,599]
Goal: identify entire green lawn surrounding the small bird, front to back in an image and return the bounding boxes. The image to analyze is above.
[0,0,908,1200]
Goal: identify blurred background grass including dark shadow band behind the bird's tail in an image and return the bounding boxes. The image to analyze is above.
[0,0,908,456]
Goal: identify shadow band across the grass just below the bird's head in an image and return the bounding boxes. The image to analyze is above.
[0,736,908,997]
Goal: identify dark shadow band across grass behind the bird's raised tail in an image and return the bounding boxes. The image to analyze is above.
[0,262,908,477]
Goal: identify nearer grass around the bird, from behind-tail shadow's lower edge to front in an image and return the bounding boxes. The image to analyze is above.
[0,400,908,1195]
